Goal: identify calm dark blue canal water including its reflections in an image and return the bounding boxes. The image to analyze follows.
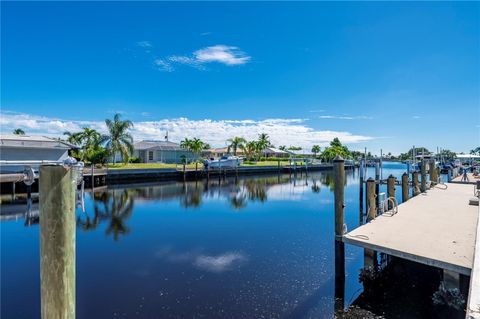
[0,163,464,319]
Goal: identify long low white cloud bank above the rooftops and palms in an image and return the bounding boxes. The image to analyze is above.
[0,111,372,149]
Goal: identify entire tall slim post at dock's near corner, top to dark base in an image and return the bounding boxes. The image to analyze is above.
[333,156,345,311]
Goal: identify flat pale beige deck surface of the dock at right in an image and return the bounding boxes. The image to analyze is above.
[343,183,479,275]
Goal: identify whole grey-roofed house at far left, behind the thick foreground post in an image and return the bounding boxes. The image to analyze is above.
[0,134,76,172]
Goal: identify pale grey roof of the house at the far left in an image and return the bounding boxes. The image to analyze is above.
[0,134,77,150]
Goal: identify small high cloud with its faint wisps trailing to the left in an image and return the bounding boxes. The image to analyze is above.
[145,41,251,72]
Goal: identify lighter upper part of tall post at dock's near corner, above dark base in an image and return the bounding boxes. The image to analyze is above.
[333,156,345,241]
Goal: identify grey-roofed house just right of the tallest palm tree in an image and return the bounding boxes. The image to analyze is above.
[133,140,198,164]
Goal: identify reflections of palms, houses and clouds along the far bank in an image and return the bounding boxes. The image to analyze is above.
[71,173,342,241]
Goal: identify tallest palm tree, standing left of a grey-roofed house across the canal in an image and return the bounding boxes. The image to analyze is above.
[102,114,133,164]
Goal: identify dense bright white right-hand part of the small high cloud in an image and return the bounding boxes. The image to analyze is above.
[193,45,251,65]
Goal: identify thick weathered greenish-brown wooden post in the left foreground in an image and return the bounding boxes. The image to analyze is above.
[39,165,77,319]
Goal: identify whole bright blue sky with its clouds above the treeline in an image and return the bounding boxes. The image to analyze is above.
[1,2,480,153]
